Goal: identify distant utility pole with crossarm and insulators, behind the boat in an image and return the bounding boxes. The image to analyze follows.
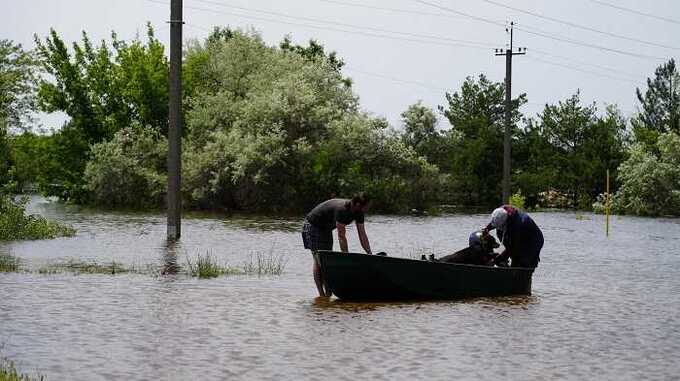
[496,22,527,204]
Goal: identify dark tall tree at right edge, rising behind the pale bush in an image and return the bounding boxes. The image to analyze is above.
[633,59,680,146]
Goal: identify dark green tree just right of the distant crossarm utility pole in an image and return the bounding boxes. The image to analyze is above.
[514,92,627,209]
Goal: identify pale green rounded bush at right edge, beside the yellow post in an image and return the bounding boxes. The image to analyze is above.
[612,133,680,216]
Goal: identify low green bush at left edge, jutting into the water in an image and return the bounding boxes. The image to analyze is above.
[0,194,76,241]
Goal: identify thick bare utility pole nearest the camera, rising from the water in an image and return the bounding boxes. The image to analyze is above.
[168,0,183,241]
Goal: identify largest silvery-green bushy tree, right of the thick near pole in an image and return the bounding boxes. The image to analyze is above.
[183,31,440,210]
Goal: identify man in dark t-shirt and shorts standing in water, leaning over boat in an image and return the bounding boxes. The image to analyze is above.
[302,193,371,296]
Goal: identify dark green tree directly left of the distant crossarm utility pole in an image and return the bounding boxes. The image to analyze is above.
[439,75,526,205]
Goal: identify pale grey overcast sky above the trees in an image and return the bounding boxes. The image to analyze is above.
[0,0,680,127]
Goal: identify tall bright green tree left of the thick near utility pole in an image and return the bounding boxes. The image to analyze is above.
[35,26,168,201]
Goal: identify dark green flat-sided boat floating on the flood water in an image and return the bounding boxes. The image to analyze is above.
[313,251,534,301]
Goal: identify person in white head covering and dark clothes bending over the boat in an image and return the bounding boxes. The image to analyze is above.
[483,205,543,268]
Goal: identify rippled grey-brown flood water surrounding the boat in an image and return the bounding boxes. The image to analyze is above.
[0,198,680,380]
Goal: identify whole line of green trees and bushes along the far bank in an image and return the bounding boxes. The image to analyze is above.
[0,26,680,215]
